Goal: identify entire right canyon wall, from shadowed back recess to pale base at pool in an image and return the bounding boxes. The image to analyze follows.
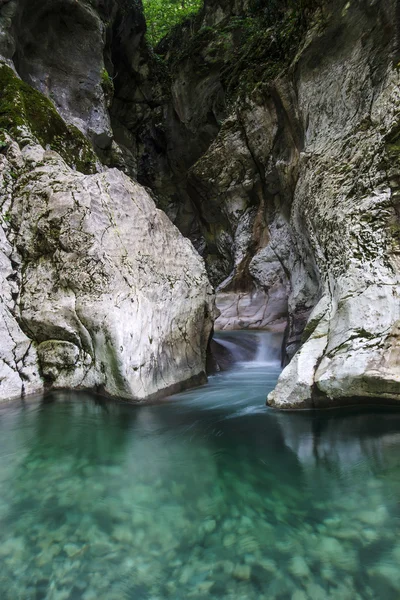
[117,0,400,408]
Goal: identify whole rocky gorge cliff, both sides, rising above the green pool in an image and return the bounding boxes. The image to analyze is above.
[0,0,400,408]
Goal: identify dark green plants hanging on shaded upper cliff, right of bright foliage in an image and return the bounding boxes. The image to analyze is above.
[159,0,323,98]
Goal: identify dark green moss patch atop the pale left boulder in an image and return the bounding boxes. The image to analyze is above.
[0,64,96,173]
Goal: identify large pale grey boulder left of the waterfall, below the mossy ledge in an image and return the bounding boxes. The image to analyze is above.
[0,59,214,401]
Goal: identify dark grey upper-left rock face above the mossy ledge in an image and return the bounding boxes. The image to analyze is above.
[0,0,148,159]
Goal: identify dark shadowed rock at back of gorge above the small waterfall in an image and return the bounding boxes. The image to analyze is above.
[104,1,298,328]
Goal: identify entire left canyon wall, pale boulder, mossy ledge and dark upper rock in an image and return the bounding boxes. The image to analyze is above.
[0,0,214,401]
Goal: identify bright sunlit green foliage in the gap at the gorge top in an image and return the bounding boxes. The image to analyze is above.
[143,0,203,46]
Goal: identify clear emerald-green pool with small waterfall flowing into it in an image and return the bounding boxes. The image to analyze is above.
[0,336,400,600]
